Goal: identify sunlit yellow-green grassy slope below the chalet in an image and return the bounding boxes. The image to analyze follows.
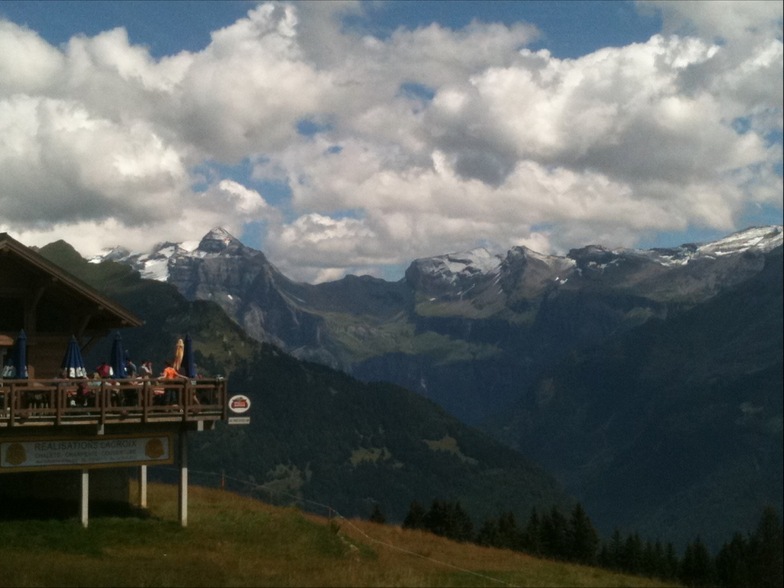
[0,484,680,587]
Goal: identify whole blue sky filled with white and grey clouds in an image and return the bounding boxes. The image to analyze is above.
[0,0,782,282]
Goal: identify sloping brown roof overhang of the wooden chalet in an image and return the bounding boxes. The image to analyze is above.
[0,233,143,332]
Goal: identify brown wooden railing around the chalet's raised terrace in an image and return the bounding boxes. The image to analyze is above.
[0,378,228,427]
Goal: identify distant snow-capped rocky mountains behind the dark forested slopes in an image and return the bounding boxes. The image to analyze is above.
[93,226,782,424]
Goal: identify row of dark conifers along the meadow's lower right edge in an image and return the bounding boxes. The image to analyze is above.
[370,499,784,588]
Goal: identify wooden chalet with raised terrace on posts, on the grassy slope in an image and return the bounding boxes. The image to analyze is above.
[0,233,236,526]
